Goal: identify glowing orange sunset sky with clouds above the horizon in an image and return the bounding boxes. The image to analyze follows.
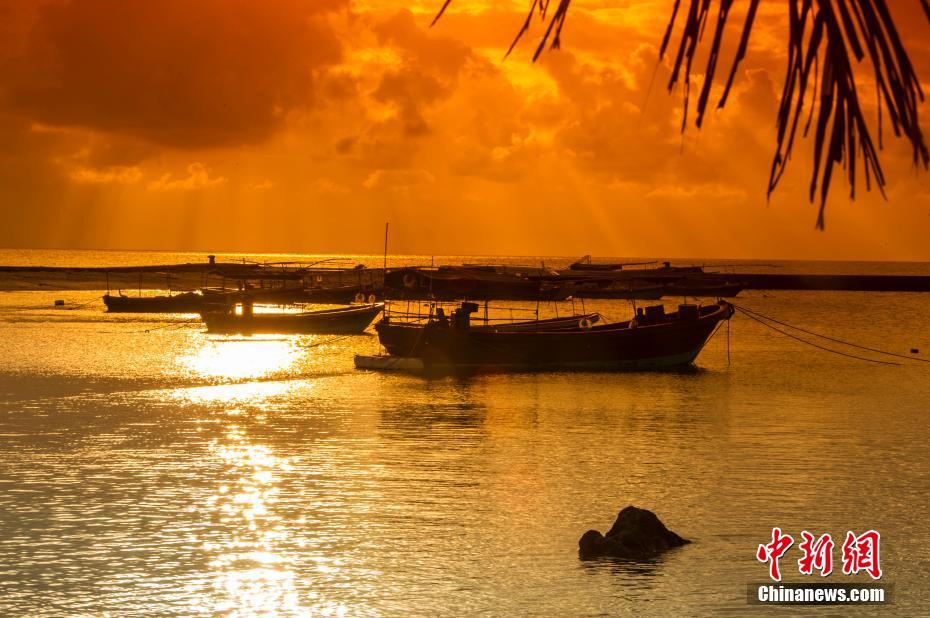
[0,0,930,260]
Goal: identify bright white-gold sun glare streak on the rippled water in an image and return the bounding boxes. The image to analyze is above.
[172,337,322,616]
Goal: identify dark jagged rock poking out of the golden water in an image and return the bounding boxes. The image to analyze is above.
[578,506,691,560]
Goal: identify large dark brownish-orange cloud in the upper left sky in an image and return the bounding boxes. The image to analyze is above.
[0,0,346,148]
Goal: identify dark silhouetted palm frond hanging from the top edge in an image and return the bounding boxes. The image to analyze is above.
[433,0,930,229]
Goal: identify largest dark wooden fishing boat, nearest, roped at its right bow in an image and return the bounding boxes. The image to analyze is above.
[362,301,734,371]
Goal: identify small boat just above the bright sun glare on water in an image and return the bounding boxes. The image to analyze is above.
[201,303,384,335]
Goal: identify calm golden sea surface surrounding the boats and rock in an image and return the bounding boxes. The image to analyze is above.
[0,251,930,616]
